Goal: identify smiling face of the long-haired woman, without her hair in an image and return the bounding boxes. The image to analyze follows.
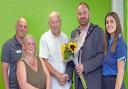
[105,16,116,36]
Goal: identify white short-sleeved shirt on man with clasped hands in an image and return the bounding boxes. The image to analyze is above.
[39,30,69,89]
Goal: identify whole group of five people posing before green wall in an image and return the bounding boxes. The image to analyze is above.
[1,2,127,89]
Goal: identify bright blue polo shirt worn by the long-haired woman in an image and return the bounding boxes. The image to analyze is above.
[103,36,127,76]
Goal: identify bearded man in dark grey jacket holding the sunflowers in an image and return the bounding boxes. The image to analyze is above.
[66,2,104,89]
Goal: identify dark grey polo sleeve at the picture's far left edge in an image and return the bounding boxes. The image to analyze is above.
[1,43,10,63]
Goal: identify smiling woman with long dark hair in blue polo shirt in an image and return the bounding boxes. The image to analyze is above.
[102,12,127,89]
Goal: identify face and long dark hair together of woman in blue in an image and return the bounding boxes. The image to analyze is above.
[104,12,122,53]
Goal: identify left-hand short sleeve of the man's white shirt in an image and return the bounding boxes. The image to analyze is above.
[39,37,49,59]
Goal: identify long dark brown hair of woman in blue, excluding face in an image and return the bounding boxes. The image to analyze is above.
[104,12,123,53]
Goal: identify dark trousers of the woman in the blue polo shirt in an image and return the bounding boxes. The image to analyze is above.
[102,75,125,89]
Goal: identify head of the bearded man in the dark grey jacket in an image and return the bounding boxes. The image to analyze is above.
[77,4,89,26]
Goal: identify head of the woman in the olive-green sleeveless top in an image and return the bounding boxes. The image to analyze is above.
[23,35,36,55]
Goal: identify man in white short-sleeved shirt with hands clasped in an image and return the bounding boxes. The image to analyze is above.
[39,11,69,89]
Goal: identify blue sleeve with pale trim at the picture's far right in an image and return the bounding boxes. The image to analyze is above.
[116,40,127,61]
